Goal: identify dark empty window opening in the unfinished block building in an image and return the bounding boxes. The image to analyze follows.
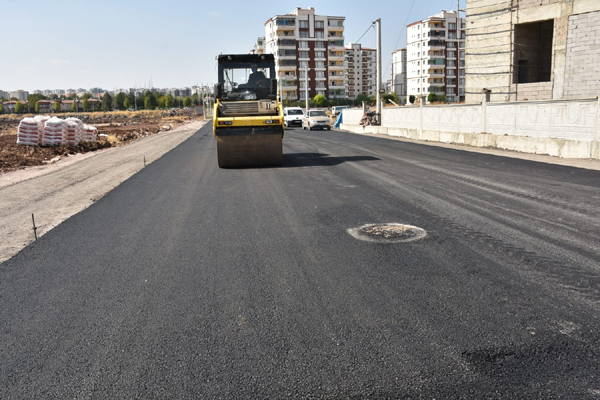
[513,20,554,83]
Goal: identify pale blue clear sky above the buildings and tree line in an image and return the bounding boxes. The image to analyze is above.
[0,0,465,92]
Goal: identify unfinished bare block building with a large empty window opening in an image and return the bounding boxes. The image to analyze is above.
[465,0,600,103]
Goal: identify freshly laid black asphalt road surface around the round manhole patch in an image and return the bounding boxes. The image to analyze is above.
[0,126,600,399]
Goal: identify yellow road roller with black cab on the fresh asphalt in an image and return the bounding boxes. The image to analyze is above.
[213,54,284,168]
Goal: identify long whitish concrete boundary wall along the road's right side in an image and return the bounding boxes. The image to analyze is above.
[341,98,600,159]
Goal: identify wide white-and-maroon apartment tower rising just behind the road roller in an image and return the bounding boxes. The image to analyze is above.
[264,7,346,100]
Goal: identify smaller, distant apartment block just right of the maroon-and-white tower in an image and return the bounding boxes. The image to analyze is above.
[345,43,377,99]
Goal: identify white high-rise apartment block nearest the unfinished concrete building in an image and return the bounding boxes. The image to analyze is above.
[406,10,465,102]
